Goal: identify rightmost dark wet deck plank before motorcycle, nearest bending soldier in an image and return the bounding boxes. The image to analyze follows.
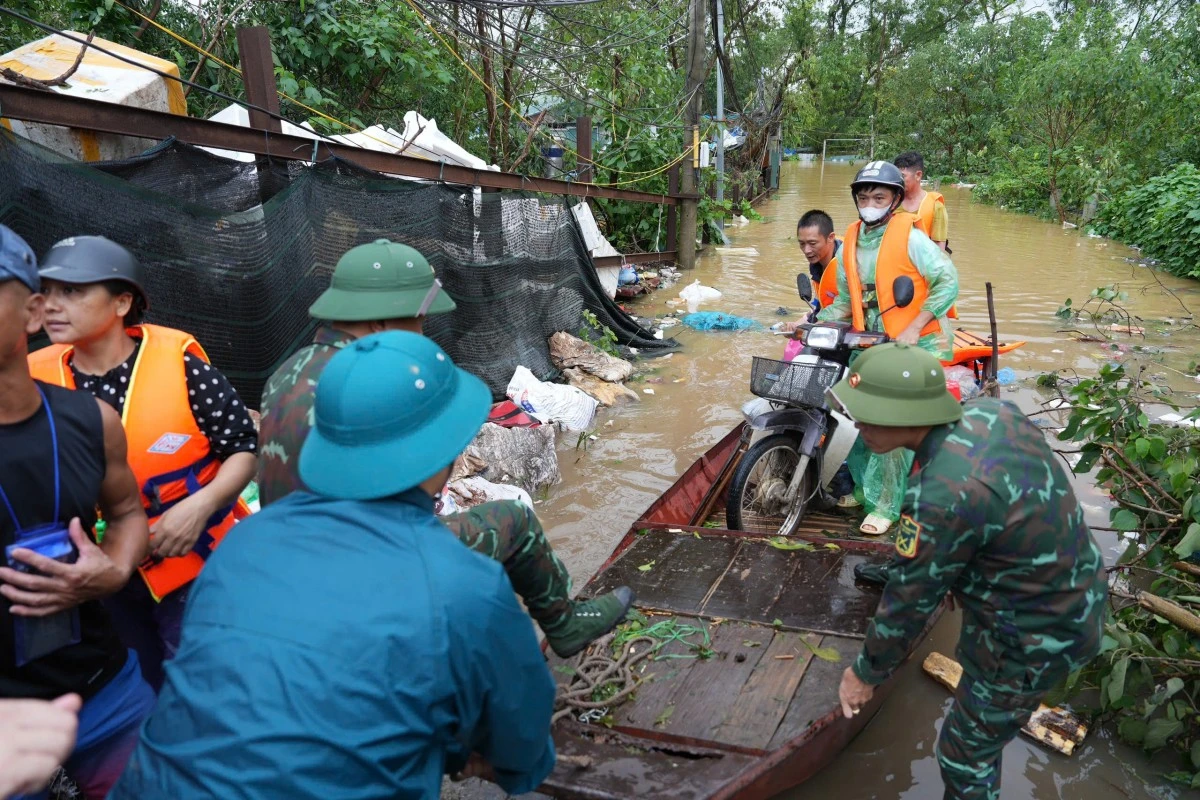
[760,549,889,636]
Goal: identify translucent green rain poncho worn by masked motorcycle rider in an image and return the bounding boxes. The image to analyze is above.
[817,220,959,522]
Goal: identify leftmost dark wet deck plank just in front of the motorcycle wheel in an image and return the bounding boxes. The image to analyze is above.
[588,530,742,614]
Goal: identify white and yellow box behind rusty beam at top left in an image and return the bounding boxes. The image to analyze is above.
[0,31,187,161]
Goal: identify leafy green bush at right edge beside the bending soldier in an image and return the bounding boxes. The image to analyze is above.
[1058,359,1200,772]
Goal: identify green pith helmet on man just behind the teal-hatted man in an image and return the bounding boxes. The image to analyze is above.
[308,239,455,323]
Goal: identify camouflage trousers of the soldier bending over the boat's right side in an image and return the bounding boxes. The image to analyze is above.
[937,664,1051,800]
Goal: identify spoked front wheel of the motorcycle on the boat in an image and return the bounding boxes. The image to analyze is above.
[725,433,815,536]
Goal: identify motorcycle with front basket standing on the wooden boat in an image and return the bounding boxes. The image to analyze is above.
[726,275,916,536]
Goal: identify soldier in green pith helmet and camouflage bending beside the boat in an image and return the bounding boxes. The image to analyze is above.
[829,344,1106,800]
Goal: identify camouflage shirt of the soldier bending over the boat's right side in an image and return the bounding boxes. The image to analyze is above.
[854,398,1106,690]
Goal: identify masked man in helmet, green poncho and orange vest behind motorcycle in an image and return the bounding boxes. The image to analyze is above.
[817,161,959,535]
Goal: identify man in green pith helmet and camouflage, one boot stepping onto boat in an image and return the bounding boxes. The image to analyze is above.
[258,239,634,657]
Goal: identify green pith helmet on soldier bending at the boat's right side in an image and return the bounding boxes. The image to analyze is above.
[829,343,962,427]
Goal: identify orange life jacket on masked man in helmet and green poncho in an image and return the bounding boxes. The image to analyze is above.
[841,215,942,338]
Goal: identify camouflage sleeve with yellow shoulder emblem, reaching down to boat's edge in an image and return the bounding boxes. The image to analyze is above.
[853,479,1002,685]
